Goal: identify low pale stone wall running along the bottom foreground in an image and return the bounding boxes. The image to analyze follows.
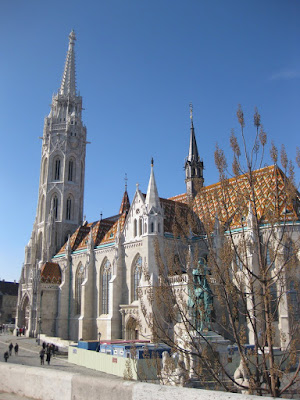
[0,363,278,400]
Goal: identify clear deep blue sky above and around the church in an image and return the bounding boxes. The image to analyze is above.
[0,0,300,280]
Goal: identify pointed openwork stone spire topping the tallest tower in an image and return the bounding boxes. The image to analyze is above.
[59,30,76,96]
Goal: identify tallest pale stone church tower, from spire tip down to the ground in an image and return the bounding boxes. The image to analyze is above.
[16,31,86,336]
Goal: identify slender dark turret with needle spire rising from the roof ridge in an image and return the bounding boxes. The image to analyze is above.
[184,105,204,199]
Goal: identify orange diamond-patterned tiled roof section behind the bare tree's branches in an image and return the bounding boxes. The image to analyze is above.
[194,166,300,229]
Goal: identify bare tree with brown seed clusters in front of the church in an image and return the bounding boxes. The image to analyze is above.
[140,106,300,397]
